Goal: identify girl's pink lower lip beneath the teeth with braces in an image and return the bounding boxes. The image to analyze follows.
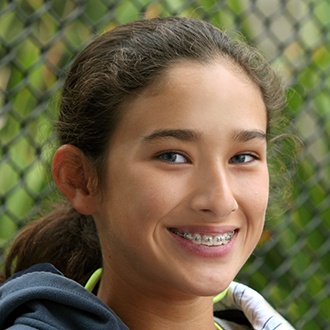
[170,231,238,258]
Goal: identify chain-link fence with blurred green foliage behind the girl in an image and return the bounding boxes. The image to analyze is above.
[0,0,330,330]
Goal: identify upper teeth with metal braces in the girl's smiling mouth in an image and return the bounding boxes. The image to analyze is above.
[169,228,235,246]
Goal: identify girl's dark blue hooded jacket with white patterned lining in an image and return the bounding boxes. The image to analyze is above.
[0,264,293,330]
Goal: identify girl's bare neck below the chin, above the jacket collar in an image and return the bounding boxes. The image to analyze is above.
[98,266,215,330]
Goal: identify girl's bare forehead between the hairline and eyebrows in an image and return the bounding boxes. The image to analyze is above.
[112,61,267,144]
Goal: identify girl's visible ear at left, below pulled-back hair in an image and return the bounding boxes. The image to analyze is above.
[52,144,98,215]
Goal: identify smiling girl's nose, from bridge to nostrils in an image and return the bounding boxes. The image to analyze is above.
[190,166,238,220]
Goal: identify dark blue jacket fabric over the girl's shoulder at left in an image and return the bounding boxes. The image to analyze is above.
[0,264,128,330]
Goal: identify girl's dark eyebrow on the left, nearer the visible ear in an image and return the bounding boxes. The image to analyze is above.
[143,129,200,142]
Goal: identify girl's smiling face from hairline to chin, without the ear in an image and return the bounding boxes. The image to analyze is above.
[94,62,268,297]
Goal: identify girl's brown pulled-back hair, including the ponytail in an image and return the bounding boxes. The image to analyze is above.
[2,17,285,284]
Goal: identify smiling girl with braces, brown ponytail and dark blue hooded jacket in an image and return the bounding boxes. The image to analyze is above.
[0,18,292,330]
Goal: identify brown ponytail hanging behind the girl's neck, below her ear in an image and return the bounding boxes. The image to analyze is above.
[0,202,102,285]
